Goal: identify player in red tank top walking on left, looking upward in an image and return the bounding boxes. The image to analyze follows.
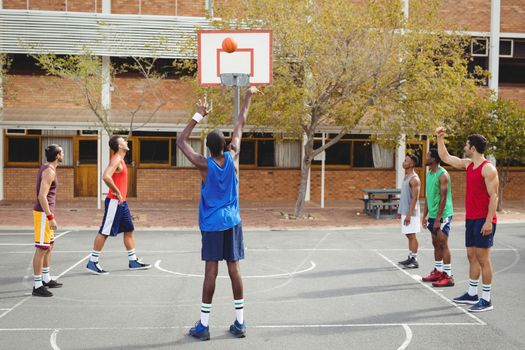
[86,135,151,275]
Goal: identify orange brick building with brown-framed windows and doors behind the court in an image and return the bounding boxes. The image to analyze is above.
[0,0,525,205]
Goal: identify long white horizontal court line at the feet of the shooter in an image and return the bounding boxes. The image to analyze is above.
[0,322,482,332]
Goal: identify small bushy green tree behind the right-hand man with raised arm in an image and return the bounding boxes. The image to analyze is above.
[450,99,525,211]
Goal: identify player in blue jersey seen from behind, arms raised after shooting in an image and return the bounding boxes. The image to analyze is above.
[177,87,258,340]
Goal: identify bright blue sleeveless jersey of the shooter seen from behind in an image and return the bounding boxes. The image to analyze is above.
[199,152,241,232]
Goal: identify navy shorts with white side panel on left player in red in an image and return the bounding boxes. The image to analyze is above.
[98,198,135,236]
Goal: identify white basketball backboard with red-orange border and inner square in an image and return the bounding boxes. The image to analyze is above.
[198,30,272,86]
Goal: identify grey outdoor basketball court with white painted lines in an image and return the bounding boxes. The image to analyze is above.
[0,222,525,349]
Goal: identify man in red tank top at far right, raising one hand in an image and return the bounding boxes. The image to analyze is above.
[436,127,499,312]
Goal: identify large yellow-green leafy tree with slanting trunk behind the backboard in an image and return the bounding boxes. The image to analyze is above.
[195,0,486,217]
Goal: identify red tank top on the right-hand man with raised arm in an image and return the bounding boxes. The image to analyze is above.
[465,159,497,223]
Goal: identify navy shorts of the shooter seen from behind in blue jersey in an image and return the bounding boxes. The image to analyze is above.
[201,224,244,261]
